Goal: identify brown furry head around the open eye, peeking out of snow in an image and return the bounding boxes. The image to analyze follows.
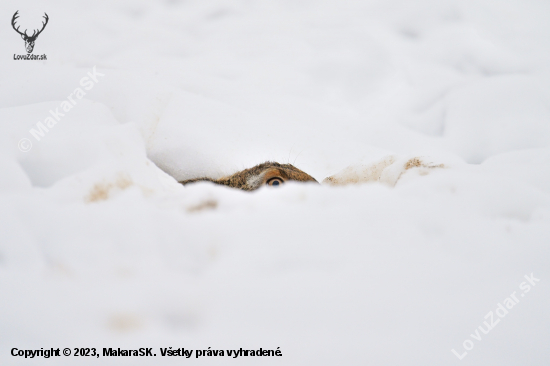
[180,161,317,191]
